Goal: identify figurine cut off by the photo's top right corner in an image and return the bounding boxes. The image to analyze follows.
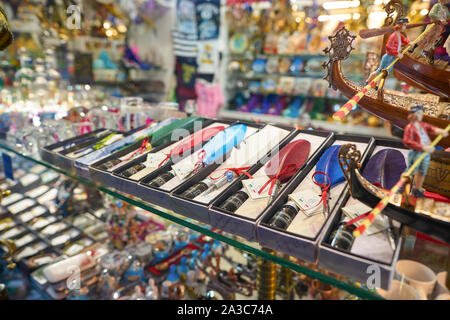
[409,0,450,64]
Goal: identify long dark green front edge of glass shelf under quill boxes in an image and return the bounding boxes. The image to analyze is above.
[0,140,383,300]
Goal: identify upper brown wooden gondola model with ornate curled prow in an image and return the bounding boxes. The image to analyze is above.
[324,28,450,148]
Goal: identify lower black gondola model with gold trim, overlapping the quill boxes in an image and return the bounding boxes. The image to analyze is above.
[339,145,450,243]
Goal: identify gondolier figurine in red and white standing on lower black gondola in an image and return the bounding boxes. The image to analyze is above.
[403,106,448,197]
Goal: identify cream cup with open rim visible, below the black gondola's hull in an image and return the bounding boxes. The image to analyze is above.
[396,260,436,296]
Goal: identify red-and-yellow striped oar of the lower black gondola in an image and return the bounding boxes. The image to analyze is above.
[353,124,450,237]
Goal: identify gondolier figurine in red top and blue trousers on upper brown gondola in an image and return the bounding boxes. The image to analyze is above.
[366,18,409,90]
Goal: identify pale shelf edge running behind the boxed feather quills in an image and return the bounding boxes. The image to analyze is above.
[218,108,392,138]
